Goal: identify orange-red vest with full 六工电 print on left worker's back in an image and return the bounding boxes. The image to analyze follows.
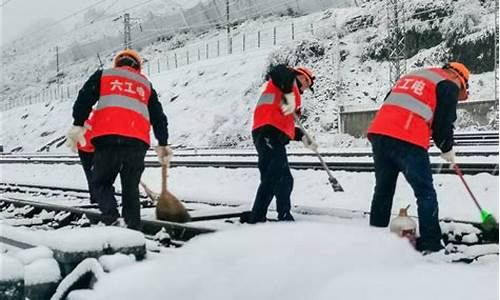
[92,67,151,145]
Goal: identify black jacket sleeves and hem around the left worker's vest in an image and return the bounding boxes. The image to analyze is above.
[73,70,168,147]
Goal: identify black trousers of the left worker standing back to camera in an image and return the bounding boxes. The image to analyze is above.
[92,144,146,229]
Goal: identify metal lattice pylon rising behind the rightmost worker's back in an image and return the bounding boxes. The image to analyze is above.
[387,0,406,85]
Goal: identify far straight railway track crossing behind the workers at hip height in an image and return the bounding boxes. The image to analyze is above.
[0,131,499,175]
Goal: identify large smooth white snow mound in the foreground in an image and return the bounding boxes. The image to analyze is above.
[88,222,497,300]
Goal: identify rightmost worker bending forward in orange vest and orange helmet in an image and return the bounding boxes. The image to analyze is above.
[368,62,469,252]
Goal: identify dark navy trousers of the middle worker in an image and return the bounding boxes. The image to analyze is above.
[249,135,293,223]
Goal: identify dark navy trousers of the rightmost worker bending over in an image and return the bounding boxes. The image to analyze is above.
[370,135,442,251]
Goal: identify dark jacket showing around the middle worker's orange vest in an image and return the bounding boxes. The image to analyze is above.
[252,65,304,145]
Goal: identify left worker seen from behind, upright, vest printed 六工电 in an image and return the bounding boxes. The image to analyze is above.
[67,49,172,229]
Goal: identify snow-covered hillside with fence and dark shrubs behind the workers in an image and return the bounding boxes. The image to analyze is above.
[0,0,498,151]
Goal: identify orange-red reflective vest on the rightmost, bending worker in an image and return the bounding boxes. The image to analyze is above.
[368,68,451,149]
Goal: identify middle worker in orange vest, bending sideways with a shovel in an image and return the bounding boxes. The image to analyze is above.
[246,65,318,223]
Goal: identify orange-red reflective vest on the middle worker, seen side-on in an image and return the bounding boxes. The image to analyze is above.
[252,80,301,140]
